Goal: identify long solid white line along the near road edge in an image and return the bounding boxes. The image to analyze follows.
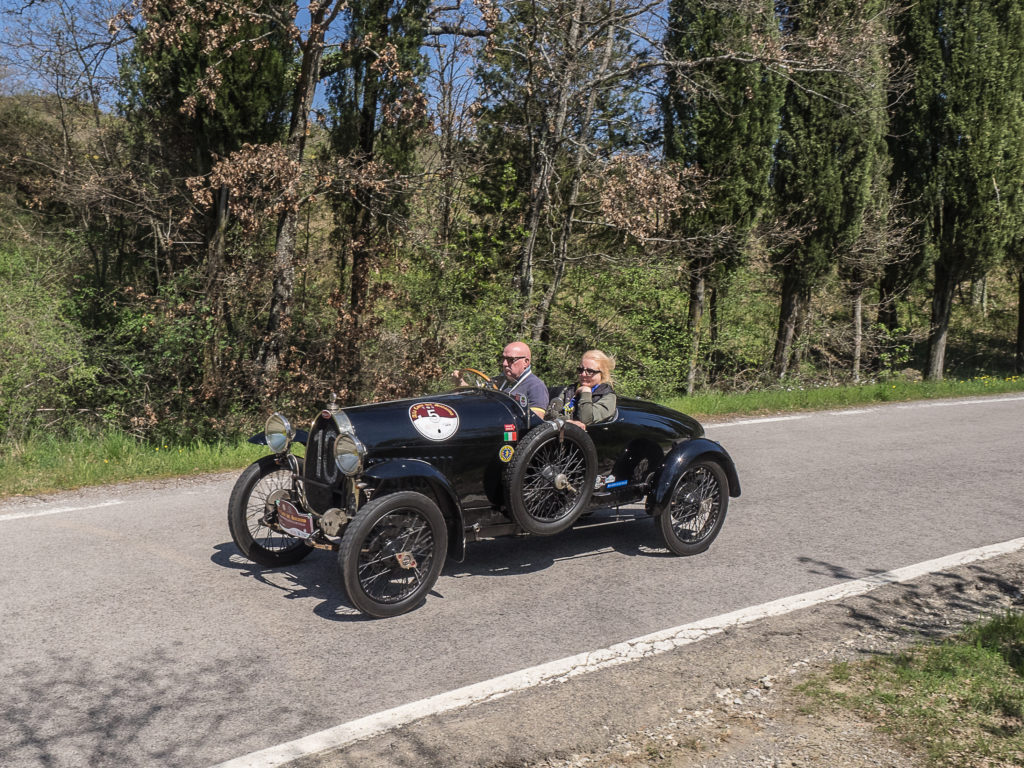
[207,539,1024,768]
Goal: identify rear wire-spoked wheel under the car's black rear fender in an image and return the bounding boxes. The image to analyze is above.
[657,461,729,556]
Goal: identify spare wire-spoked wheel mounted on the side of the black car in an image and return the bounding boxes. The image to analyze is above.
[505,422,597,536]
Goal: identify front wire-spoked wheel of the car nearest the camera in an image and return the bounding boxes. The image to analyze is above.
[338,490,447,618]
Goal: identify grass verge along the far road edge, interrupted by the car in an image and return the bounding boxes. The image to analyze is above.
[0,376,1024,499]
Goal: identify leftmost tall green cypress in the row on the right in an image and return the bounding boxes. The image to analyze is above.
[662,0,784,393]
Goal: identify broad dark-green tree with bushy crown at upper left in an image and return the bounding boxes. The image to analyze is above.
[121,0,295,404]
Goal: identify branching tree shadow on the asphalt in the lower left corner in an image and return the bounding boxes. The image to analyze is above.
[0,647,306,768]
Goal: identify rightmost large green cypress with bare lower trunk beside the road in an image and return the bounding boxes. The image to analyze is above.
[893,0,1024,380]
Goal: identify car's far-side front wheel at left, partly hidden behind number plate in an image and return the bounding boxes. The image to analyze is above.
[227,456,312,568]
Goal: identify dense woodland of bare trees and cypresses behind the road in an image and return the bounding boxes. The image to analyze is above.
[0,0,1024,441]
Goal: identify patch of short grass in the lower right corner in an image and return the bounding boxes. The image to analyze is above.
[803,612,1024,768]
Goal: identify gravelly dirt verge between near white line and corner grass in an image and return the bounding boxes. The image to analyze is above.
[309,551,1024,768]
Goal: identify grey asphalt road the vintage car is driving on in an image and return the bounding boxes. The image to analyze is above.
[0,396,1024,768]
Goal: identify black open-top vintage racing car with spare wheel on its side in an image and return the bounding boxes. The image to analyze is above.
[227,369,739,617]
